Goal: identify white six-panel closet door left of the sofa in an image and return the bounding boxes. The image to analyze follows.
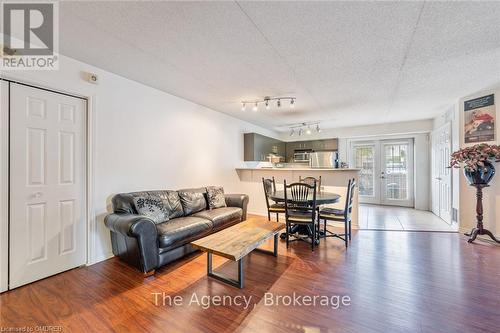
[9,83,86,289]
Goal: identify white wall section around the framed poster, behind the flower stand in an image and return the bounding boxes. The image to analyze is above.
[458,83,500,239]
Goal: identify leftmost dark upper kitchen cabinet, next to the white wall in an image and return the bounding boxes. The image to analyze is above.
[244,133,286,161]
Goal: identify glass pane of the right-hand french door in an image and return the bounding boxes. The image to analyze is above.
[384,144,408,200]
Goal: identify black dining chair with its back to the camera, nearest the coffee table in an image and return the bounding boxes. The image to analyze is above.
[284,180,319,251]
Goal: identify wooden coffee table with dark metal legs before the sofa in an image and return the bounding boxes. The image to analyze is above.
[191,220,285,288]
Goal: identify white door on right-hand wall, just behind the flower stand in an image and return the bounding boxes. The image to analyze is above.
[432,124,452,223]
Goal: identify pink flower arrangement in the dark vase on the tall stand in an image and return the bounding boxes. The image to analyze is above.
[450,143,500,171]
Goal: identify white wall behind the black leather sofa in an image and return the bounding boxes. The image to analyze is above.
[0,57,277,263]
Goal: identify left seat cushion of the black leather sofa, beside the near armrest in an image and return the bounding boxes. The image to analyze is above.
[156,216,212,248]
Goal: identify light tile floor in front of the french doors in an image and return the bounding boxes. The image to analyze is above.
[359,204,458,232]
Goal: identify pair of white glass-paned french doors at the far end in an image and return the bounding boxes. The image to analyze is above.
[351,139,414,207]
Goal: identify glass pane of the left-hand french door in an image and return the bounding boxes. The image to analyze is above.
[353,146,375,196]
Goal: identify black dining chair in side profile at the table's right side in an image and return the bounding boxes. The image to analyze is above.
[318,178,356,248]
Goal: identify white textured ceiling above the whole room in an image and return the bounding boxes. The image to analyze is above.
[60,2,500,129]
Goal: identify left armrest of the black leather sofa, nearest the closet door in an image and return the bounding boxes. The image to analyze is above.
[104,213,159,273]
